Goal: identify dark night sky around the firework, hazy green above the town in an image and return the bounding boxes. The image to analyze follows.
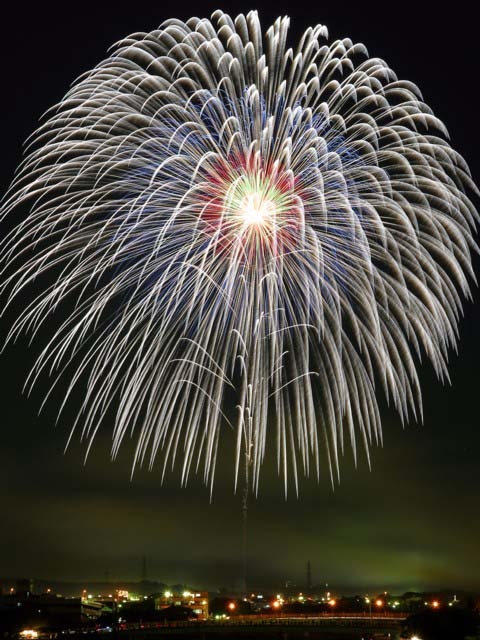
[0,0,480,590]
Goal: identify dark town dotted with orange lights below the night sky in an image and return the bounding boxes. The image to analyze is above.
[0,576,480,640]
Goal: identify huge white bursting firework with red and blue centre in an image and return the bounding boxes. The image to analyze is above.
[1,12,477,490]
